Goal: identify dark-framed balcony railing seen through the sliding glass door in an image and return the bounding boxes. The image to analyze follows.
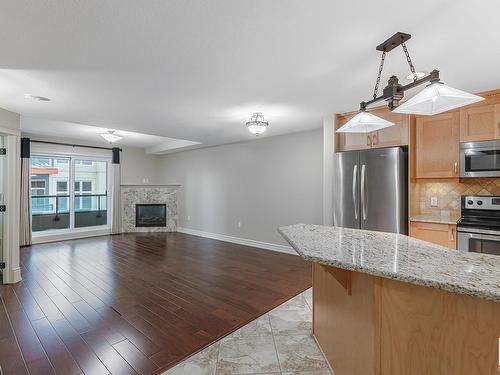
[31,194,108,232]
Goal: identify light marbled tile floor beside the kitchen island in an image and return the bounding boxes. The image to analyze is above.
[160,289,332,375]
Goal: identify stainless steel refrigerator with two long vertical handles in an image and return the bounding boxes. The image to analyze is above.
[333,147,408,234]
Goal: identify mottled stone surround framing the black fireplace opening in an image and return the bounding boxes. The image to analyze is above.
[121,185,180,233]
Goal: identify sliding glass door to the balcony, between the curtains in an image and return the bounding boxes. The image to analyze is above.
[31,155,109,232]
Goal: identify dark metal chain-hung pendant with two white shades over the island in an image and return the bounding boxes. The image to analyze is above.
[337,32,484,133]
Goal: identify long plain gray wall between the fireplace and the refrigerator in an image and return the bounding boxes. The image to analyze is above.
[160,129,323,245]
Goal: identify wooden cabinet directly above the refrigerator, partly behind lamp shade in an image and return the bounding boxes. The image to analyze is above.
[336,107,410,151]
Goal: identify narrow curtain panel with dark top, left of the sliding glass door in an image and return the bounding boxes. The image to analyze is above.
[19,138,31,246]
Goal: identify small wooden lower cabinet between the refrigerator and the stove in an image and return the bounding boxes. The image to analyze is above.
[410,221,457,249]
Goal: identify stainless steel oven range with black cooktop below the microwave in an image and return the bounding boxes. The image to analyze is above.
[457,195,500,255]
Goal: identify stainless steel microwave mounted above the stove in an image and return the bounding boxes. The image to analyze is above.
[460,140,500,177]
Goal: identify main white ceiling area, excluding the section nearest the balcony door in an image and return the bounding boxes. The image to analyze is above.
[0,0,500,150]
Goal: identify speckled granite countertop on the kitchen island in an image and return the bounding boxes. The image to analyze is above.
[279,224,500,302]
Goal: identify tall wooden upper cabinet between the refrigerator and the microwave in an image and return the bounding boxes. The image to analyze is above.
[416,111,460,178]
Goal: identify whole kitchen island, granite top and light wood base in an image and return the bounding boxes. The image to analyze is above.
[279,224,500,375]
